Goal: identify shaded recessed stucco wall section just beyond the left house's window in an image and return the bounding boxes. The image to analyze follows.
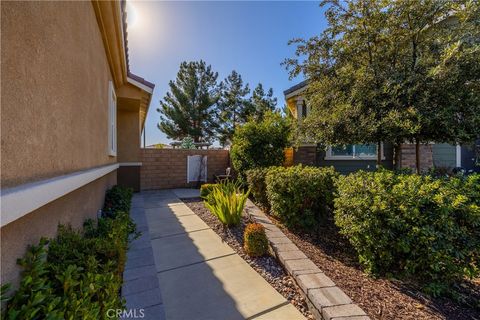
[117,110,140,162]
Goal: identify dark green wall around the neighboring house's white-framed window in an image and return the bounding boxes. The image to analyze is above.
[317,143,393,174]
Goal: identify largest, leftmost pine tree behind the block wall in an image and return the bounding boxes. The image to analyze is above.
[157,60,220,142]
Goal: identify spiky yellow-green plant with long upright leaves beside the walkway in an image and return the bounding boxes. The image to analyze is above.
[204,181,250,227]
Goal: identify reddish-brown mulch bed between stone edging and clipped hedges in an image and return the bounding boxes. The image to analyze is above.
[264,210,480,320]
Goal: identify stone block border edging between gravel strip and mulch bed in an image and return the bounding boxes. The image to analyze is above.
[245,200,370,320]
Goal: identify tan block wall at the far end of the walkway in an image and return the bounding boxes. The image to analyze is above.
[140,149,230,190]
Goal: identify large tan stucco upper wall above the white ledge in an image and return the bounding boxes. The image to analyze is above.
[1,1,116,188]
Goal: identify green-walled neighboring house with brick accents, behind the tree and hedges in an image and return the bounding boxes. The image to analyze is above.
[283,81,480,173]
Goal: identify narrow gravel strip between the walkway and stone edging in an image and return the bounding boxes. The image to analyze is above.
[182,198,313,319]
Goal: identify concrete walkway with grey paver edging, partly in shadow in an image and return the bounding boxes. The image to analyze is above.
[124,189,304,320]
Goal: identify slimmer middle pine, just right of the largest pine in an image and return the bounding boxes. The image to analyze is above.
[218,70,250,146]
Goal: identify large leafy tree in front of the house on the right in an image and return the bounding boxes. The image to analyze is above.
[285,0,480,172]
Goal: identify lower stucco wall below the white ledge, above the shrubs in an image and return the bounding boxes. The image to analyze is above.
[1,171,117,285]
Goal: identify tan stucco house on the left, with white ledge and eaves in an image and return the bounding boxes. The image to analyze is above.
[0,1,154,284]
